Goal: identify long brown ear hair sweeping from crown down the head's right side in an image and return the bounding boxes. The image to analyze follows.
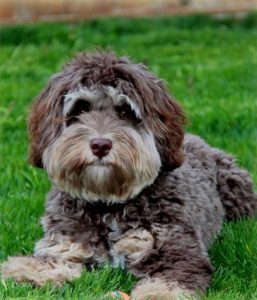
[114,58,186,169]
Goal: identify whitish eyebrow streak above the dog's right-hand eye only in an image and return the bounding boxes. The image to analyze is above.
[105,86,142,119]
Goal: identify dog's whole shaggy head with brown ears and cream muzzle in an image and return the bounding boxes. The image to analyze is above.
[29,52,184,202]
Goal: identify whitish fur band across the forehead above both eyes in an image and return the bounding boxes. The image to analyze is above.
[64,85,142,119]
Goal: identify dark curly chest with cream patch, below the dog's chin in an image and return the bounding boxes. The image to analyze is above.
[59,190,170,267]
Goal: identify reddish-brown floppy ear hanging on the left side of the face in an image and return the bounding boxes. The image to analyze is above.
[28,74,65,168]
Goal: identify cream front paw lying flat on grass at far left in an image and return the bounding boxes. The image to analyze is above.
[1,256,82,286]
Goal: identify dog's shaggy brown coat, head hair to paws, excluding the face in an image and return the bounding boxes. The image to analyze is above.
[2,53,257,300]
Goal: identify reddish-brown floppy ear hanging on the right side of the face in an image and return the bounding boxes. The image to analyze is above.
[145,77,186,169]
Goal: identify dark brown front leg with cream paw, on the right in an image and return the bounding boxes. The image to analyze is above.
[123,225,212,300]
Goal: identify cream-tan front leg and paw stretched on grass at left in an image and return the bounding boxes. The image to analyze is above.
[1,234,97,286]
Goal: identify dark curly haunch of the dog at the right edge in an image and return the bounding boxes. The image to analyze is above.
[216,151,257,220]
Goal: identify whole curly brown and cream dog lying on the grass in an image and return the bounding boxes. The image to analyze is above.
[2,52,257,300]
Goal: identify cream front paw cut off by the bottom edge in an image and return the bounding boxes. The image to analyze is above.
[131,279,194,300]
